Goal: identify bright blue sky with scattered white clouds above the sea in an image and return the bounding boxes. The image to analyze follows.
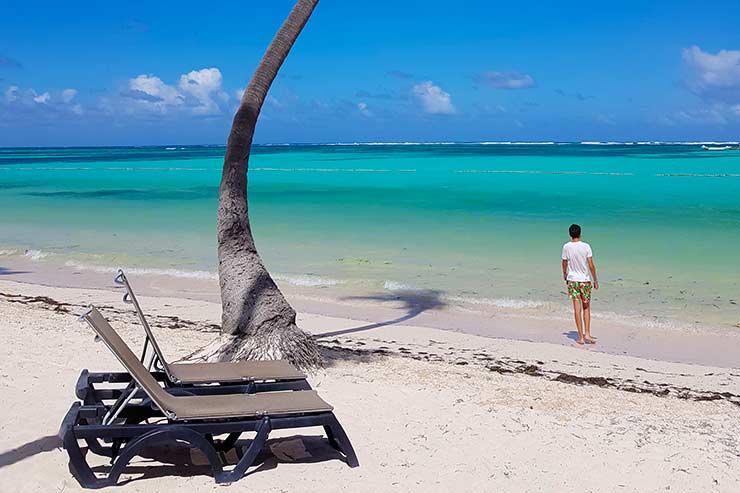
[0,0,740,146]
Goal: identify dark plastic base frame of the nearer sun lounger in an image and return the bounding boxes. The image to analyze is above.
[59,402,359,489]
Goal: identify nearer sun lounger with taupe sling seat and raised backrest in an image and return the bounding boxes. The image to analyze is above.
[59,307,359,488]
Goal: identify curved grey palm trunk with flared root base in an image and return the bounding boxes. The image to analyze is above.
[195,0,321,369]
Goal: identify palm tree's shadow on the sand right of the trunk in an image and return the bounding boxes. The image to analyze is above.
[314,289,447,339]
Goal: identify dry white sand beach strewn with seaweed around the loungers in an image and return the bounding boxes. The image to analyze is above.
[0,281,740,492]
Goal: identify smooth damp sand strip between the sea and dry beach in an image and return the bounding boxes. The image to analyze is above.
[0,252,740,369]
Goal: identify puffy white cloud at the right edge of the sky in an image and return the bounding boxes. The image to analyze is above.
[682,46,740,103]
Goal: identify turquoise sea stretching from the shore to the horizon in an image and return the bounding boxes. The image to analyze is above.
[0,143,740,328]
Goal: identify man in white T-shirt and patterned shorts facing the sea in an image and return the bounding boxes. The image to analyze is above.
[562,224,599,344]
